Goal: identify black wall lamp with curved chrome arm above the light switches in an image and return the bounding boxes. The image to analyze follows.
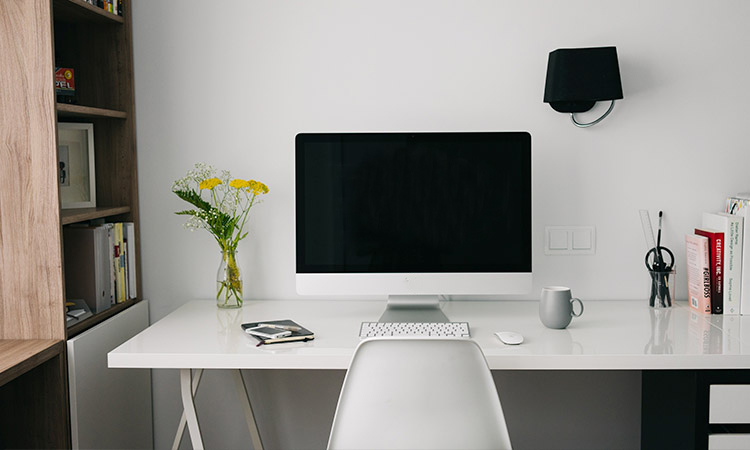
[544,47,623,128]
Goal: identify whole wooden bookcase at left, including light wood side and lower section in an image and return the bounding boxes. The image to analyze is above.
[0,0,141,448]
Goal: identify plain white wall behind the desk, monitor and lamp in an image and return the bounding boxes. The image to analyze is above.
[133,0,750,448]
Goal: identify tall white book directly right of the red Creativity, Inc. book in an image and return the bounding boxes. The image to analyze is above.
[703,213,744,315]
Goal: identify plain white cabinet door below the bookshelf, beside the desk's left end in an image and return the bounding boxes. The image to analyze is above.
[68,301,153,449]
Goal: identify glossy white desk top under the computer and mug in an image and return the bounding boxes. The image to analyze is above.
[108,300,750,370]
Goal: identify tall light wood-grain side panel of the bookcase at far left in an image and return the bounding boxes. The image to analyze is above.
[0,0,65,339]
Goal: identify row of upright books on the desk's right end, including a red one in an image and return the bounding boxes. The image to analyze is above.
[685,194,750,315]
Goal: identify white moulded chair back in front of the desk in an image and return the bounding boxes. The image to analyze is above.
[328,337,511,450]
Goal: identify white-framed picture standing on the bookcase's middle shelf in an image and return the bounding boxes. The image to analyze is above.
[57,122,96,209]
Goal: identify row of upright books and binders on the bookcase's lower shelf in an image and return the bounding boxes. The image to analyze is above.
[63,222,138,313]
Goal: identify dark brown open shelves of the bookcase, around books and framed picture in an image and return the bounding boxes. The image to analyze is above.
[52,0,141,337]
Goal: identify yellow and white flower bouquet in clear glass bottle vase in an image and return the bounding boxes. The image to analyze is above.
[172,163,268,308]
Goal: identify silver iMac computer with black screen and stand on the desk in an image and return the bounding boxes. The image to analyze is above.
[295,132,531,322]
